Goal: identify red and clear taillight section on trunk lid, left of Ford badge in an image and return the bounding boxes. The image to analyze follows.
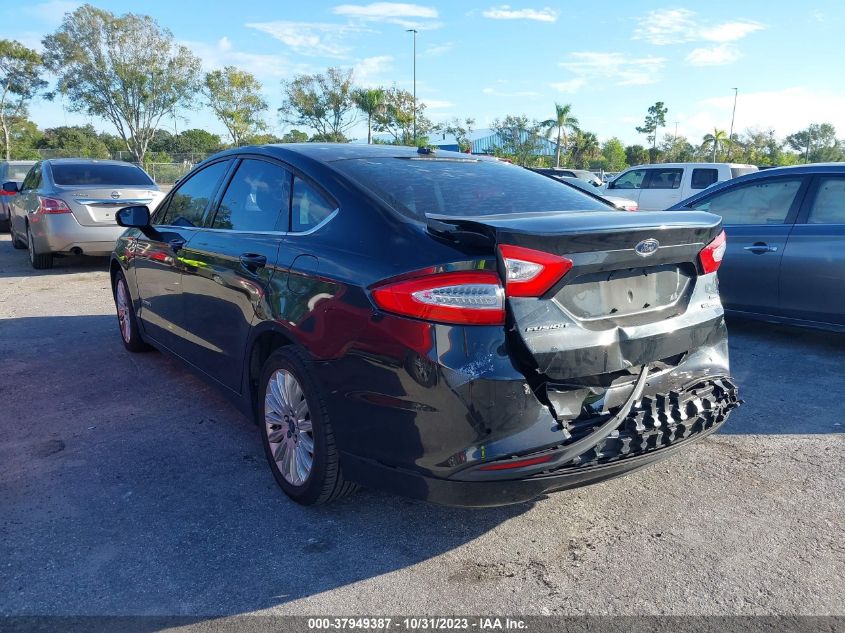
[499,244,572,297]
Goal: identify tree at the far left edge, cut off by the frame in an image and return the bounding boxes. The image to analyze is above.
[0,40,47,160]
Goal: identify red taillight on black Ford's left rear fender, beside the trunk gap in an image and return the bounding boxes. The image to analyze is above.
[373,271,505,325]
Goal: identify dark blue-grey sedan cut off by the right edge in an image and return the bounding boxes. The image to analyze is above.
[673,163,845,329]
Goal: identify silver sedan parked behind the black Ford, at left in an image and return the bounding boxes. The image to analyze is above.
[3,158,163,268]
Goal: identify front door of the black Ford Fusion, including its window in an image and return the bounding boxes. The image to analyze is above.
[131,159,232,356]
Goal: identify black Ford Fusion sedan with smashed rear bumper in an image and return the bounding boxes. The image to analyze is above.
[110,143,737,506]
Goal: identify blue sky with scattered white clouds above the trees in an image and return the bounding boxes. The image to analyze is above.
[6,0,845,143]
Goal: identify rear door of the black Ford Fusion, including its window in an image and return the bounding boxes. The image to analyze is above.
[176,157,292,392]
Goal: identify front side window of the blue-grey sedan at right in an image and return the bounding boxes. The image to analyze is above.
[690,178,801,224]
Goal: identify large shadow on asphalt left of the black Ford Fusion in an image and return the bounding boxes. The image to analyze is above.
[0,315,533,616]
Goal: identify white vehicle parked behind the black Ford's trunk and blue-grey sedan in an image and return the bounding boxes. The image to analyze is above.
[602,163,757,211]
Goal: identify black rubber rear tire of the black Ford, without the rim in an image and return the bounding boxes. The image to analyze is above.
[256,347,358,506]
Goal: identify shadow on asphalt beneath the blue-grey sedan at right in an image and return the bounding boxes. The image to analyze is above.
[721,317,845,434]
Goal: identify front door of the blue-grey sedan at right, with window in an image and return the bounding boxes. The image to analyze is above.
[688,175,807,314]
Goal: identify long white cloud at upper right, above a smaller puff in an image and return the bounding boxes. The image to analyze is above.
[634,9,766,46]
